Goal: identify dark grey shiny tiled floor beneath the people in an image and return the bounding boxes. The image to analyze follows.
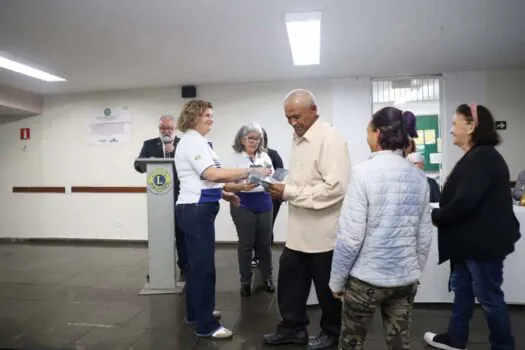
[0,244,525,350]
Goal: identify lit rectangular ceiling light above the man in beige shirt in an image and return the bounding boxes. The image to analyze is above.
[285,12,321,66]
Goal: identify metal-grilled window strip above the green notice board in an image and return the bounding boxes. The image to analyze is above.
[372,78,439,103]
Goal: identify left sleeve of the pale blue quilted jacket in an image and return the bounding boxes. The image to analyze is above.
[329,168,368,293]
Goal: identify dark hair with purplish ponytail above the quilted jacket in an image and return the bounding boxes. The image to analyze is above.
[371,107,417,151]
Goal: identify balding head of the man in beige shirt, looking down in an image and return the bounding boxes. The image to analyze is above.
[284,89,319,137]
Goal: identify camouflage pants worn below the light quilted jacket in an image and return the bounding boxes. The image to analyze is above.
[339,278,417,350]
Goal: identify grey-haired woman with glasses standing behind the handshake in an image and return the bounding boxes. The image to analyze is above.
[224,123,275,297]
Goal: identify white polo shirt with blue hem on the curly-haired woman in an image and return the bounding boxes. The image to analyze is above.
[175,130,224,204]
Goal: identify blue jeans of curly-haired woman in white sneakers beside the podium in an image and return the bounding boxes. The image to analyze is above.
[176,202,221,336]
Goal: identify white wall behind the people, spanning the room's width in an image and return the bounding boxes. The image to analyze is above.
[0,70,525,241]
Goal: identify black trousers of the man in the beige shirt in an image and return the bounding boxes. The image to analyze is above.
[277,247,342,336]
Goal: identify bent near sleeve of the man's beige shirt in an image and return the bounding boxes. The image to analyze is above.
[283,135,350,209]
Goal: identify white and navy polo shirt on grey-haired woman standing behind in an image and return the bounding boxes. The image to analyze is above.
[229,152,274,212]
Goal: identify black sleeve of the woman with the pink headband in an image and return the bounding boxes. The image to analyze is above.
[432,150,491,227]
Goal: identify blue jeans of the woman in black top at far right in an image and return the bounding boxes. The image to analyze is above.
[448,260,515,350]
